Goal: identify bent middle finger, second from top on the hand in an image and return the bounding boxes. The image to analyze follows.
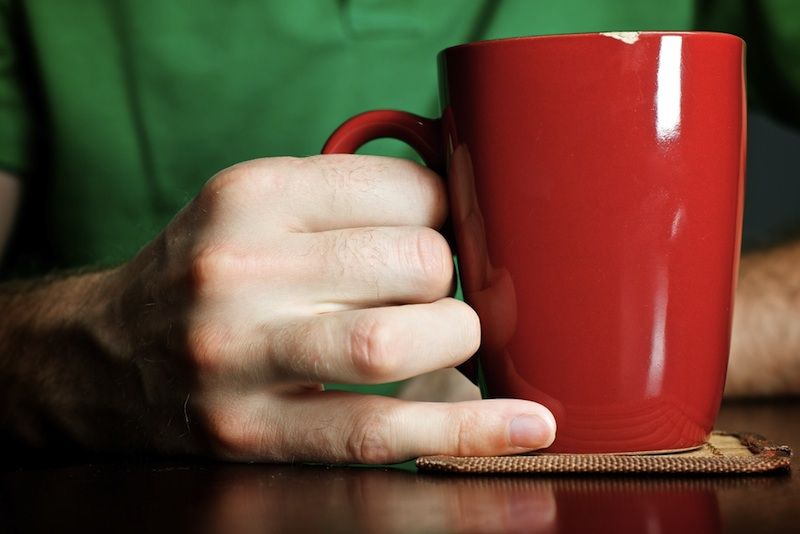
[290,226,453,311]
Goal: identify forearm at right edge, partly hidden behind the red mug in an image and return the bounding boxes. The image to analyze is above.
[725,241,800,396]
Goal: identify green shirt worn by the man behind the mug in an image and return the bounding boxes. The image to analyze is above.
[0,0,800,394]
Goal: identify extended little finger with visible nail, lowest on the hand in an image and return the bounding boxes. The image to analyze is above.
[212,391,556,464]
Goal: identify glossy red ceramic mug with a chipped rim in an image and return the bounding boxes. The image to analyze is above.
[323,32,746,453]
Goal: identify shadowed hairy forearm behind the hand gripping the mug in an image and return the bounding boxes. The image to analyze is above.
[0,272,141,448]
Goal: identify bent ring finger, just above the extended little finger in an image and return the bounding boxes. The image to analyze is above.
[262,298,480,384]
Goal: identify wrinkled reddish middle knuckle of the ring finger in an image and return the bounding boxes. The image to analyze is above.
[349,316,397,382]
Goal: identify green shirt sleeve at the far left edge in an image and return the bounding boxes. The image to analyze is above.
[0,1,31,175]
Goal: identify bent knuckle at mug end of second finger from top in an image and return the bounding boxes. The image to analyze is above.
[401,228,453,290]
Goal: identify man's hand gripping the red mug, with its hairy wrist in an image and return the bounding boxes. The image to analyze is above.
[0,155,555,463]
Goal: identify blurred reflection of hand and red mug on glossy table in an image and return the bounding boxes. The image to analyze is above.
[200,468,732,534]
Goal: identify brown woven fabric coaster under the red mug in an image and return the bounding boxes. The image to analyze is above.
[417,431,792,474]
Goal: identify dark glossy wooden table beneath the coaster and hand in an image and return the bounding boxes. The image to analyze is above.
[0,400,800,534]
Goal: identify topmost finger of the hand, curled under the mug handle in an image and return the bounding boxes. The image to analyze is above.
[234,154,447,232]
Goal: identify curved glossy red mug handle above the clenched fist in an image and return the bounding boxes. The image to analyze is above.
[322,109,444,175]
